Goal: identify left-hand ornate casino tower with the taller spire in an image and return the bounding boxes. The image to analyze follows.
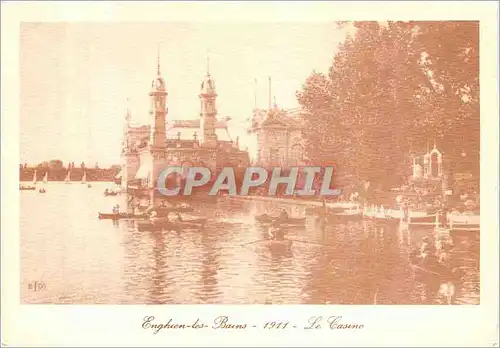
[149,55,168,148]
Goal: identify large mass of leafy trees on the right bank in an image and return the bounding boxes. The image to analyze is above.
[297,21,480,196]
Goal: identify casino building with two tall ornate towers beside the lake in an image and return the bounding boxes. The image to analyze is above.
[119,56,249,191]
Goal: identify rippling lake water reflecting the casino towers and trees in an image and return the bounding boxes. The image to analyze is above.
[20,182,479,304]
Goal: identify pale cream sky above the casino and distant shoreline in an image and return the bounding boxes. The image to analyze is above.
[20,22,347,166]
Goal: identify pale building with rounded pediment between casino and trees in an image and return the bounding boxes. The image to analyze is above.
[251,103,306,167]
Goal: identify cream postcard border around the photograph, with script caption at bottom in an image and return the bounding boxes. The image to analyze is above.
[1,1,499,347]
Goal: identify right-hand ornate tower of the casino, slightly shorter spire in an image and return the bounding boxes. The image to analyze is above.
[199,59,217,147]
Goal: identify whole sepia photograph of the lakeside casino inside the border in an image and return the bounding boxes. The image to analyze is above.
[19,21,481,305]
